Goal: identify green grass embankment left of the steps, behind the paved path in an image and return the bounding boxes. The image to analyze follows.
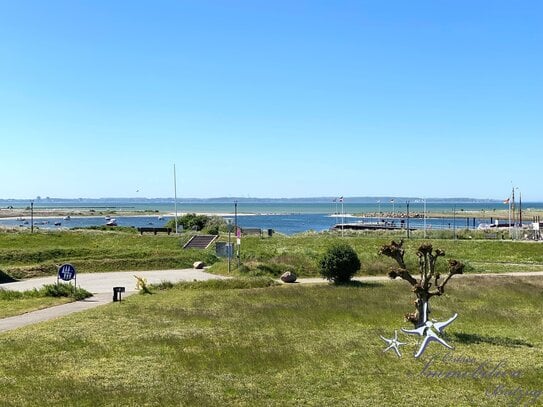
[0,230,216,278]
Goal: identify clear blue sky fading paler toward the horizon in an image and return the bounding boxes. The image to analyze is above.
[0,0,543,201]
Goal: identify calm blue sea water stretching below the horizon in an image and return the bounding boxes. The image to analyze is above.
[0,201,543,235]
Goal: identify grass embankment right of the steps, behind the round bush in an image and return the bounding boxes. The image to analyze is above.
[219,234,543,277]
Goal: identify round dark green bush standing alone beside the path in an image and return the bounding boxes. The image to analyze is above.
[319,243,360,284]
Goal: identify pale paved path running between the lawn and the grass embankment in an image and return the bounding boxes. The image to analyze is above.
[0,269,543,333]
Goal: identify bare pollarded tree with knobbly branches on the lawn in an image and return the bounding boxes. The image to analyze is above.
[379,240,464,328]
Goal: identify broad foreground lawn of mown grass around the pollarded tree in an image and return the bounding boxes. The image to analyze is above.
[0,277,543,406]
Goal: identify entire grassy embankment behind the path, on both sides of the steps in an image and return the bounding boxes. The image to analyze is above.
[0,230,543,279]
